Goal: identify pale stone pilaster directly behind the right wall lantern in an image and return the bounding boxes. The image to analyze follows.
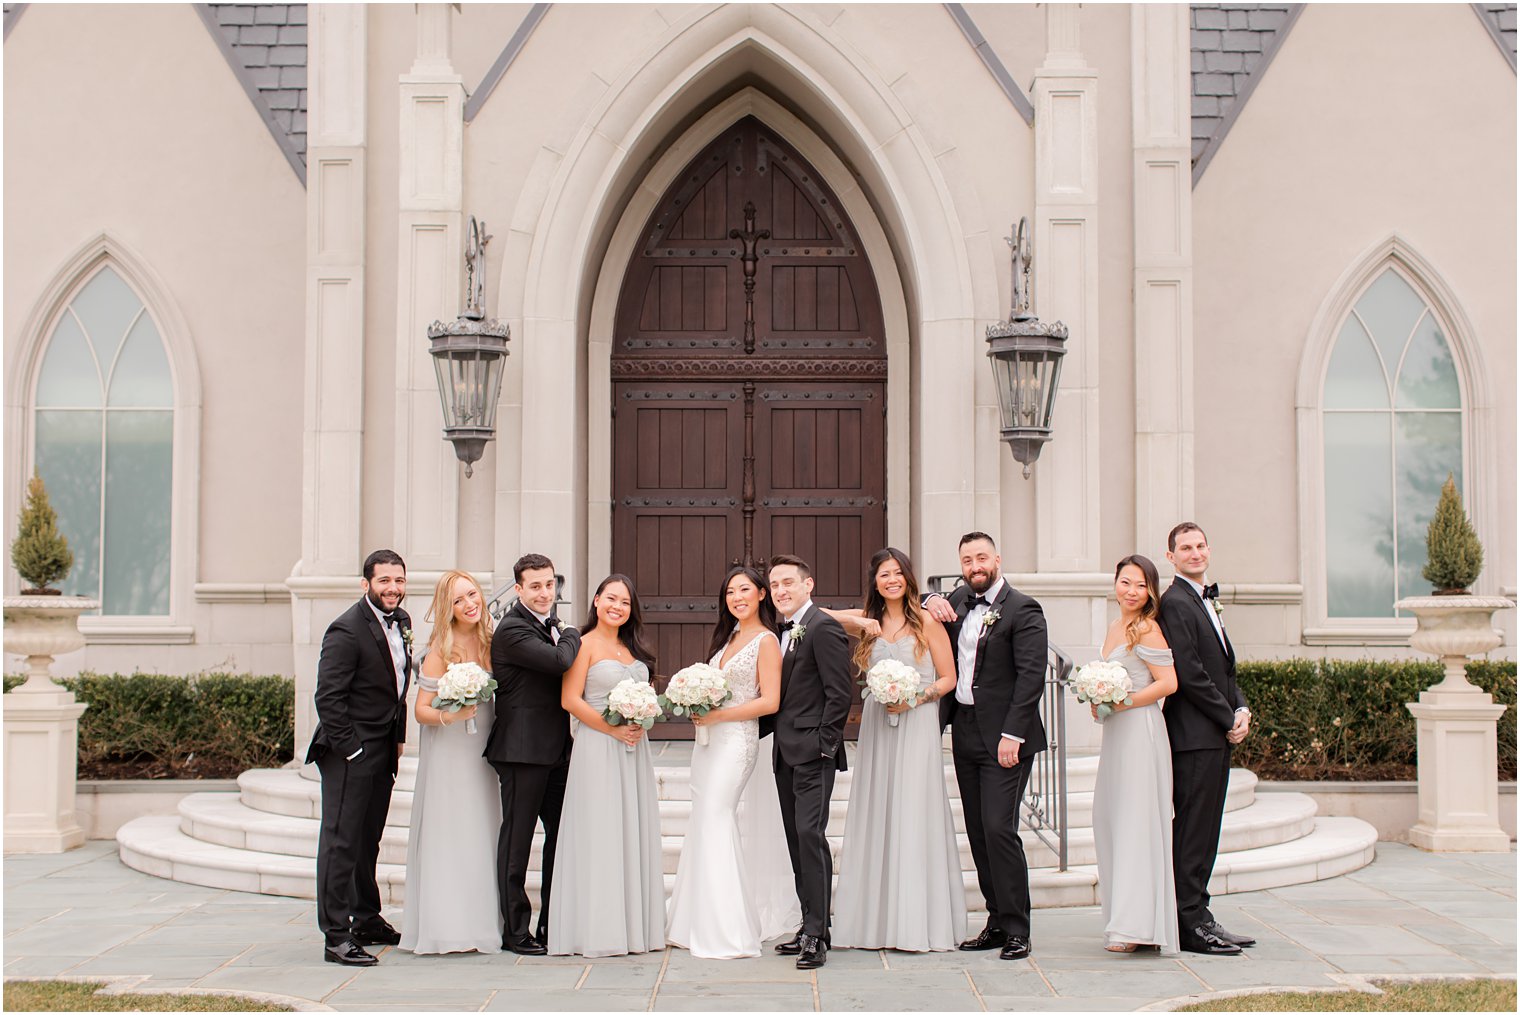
[1033,3,1107,577]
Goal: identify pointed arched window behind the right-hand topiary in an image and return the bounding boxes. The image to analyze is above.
[1322,264,1464,620]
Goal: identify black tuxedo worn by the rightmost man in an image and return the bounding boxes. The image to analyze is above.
[1160,577,1245,936]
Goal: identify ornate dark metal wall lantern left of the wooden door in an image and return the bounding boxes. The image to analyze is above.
[427,216,511,477]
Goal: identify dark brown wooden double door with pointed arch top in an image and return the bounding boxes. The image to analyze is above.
[613,117,886,698]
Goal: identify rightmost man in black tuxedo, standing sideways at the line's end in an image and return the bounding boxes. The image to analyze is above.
[1161,521,1256,956]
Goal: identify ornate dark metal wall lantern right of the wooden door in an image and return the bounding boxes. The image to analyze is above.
[986,219,1067,479]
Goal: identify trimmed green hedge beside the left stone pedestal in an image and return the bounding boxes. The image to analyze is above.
[5,673,295,779]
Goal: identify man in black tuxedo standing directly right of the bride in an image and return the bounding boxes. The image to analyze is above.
[760,555,854,969]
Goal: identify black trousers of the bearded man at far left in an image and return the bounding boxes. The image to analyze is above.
[316,738,397,945]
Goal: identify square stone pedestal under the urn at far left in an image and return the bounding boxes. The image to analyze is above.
[5,685,87,852]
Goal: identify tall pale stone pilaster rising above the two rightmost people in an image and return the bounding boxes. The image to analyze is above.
[1129,5,1196,558]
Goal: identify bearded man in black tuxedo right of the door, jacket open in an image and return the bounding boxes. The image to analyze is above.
[924,532,1049,959]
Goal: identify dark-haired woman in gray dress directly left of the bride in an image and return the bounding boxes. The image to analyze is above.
[549,574,666,956]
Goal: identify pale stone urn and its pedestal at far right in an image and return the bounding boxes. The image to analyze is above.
[1395,596,1514,852]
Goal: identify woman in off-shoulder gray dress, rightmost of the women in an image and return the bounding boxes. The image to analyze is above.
[1093,555,1178,956]
